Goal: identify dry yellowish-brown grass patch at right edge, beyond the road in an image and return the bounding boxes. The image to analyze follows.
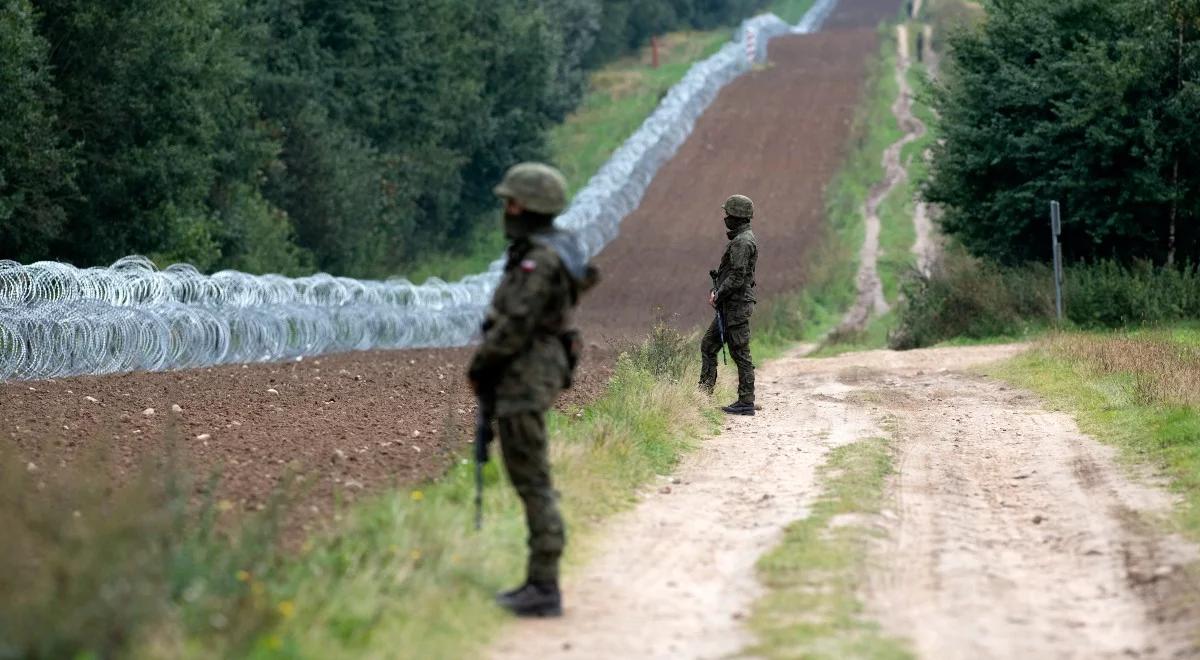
[1048,332,1200,407]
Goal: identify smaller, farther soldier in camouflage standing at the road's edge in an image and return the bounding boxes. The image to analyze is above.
[700,194,758,415]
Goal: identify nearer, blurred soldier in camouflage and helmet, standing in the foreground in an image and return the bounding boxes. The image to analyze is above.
[468,163,596,616]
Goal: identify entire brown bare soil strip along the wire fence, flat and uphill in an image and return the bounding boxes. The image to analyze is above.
[0,12,895,517]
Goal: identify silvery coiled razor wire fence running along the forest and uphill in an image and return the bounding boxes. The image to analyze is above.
[0,0,836,380]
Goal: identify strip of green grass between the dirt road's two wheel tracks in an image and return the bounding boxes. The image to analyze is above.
[746,438,912,659]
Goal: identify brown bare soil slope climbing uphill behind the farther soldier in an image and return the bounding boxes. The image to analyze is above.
[580,30,877,337]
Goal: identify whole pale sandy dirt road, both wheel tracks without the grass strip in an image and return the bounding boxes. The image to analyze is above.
[492,346,1200,660]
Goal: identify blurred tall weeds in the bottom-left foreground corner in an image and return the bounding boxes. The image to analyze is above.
[0,443,287,659]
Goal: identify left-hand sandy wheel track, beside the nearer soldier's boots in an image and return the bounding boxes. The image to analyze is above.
[492,345,878,660]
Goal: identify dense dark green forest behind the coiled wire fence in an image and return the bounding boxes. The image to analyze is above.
[0,0,766,277]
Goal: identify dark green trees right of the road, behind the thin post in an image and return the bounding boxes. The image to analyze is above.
[925,0,1200,264]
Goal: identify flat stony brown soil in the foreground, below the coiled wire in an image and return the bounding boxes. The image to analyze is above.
[0,347,612,528]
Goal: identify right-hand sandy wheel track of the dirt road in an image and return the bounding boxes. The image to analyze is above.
[869,372,1200,659]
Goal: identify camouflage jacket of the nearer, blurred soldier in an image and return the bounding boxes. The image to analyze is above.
[468,232,595,416]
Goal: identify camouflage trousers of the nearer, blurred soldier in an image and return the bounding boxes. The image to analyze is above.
[497,412,566,582]
